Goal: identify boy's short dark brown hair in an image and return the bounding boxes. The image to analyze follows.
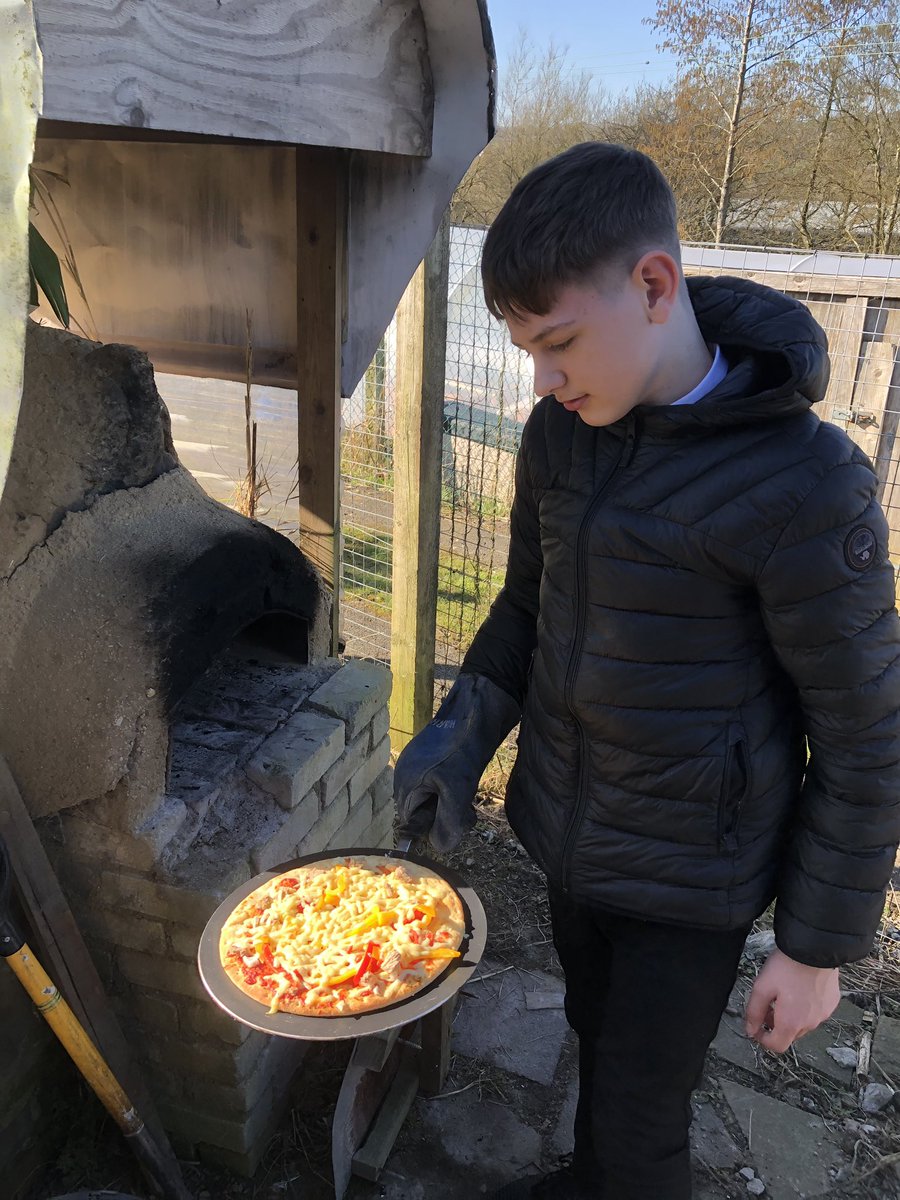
[481,142,679,317]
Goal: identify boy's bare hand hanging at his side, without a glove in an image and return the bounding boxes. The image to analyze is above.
[745,948,841,1054]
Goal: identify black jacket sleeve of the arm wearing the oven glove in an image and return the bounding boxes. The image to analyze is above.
[461,406,544,707]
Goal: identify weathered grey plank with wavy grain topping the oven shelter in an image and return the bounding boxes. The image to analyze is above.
[35,0,432,155]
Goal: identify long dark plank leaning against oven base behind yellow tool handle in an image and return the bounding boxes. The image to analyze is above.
[0,755,174,1147]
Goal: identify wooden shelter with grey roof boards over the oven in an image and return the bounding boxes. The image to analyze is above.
[35,0,494,614]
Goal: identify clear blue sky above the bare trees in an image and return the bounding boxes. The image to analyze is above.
[487,0,674,94]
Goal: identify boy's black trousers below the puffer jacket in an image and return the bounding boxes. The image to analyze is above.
[548,887,749,1200]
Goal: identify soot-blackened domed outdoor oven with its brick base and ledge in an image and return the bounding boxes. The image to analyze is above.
[0,325,392,1171]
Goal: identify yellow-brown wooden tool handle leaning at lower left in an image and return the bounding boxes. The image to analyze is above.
[6,942,144,1134]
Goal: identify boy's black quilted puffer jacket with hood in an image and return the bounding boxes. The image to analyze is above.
[463,278,900,966]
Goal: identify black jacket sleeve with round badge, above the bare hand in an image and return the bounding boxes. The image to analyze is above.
[757,451,900,967]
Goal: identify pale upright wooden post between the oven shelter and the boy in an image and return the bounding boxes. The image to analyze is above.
[390,211,450,750]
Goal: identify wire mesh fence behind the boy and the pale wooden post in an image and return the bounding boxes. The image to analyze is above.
[342,227,900,785]
